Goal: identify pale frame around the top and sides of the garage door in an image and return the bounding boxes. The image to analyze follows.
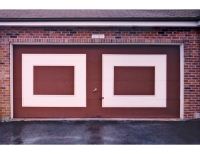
[10,42,184,120]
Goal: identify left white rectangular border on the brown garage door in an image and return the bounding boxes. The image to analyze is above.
[22,54,86,107]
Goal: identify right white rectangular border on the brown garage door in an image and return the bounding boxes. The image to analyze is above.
[102,54,167,107]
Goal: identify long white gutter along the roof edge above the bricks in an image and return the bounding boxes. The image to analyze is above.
[0,21,200,27]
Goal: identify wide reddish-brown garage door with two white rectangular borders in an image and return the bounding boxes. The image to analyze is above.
[13,45,180,118]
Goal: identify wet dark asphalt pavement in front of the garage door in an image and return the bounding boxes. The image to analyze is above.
[0,120,200,145]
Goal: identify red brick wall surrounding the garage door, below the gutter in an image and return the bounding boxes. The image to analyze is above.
[0,27,200,119]
